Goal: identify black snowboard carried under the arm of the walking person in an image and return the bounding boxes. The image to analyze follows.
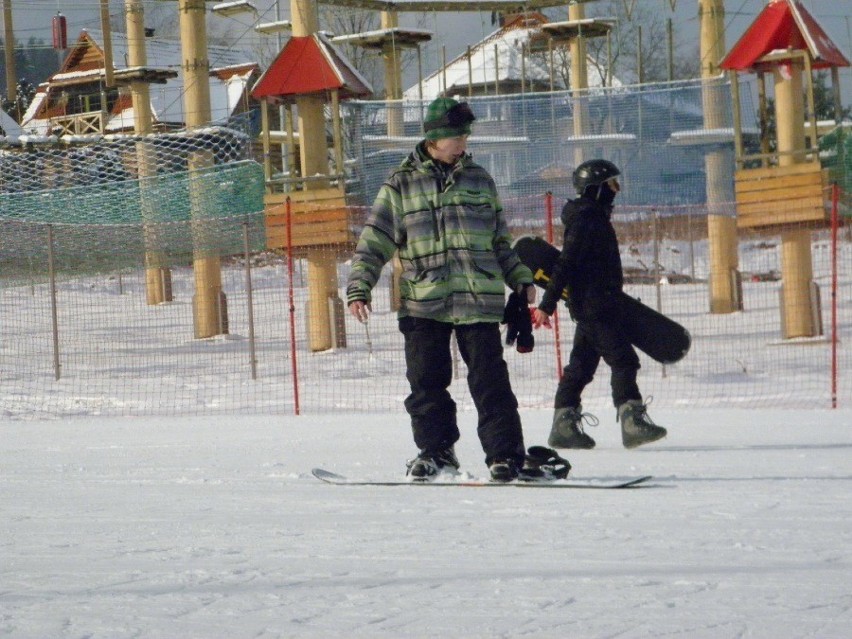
[514,235,692,364]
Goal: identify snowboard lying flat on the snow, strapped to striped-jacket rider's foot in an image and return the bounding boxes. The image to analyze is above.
[311,468,652,489]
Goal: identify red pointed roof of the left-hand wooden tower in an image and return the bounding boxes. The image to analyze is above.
[252,33,373,100]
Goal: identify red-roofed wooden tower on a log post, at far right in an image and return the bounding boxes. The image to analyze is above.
[722,0,849,339]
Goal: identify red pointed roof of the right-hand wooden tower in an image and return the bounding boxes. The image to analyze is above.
[720,0,849,71]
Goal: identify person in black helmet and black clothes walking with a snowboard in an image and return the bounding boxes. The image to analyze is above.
[533,159,666,448]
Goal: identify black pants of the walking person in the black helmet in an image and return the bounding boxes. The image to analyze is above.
[554,318,642,408]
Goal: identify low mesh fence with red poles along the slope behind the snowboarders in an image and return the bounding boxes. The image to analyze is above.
[0,198,852,418]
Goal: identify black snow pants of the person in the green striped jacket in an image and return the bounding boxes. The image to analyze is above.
[399,317,524,465]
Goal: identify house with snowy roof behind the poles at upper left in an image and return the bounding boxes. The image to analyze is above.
[21,30,259,136]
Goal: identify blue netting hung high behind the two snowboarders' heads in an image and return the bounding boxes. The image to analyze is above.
[345,79,757,205]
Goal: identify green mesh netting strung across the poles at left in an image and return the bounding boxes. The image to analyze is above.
[0,161,266,286]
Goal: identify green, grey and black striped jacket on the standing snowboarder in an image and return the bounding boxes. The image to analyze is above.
[347,142,532,324]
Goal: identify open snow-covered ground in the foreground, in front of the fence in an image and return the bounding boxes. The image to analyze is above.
[0,408,852,639]
